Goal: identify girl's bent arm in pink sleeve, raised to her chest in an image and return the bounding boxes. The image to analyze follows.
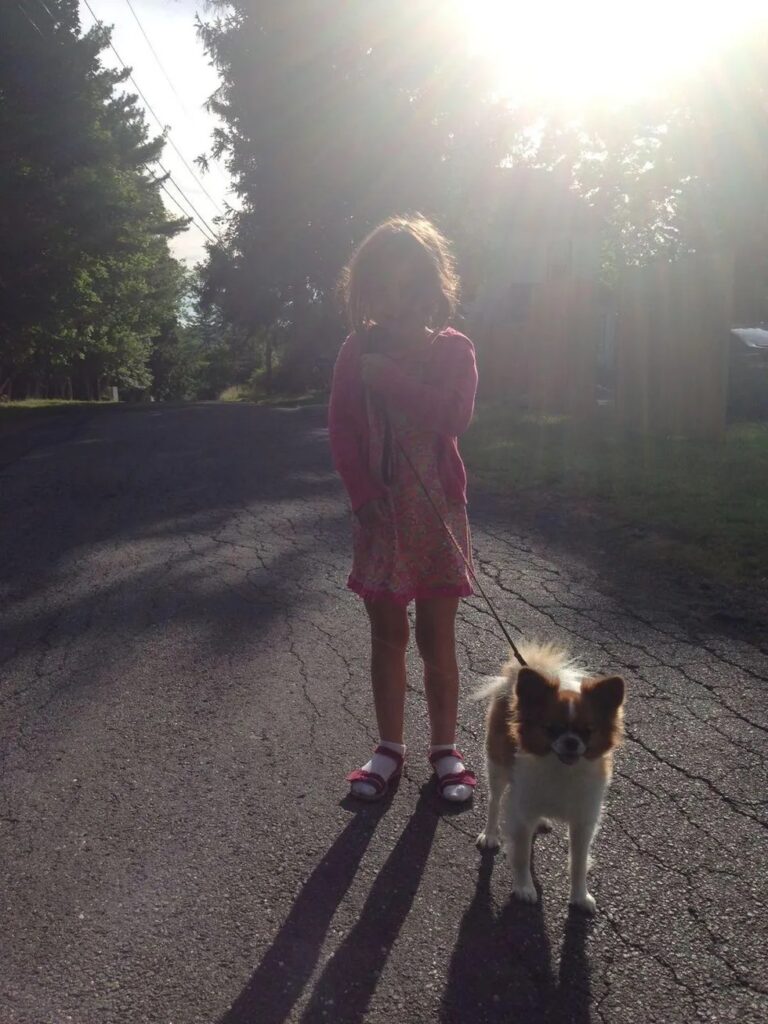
[373,334,477,437]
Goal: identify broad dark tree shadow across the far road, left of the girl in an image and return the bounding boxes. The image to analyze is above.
[0,404,338,596]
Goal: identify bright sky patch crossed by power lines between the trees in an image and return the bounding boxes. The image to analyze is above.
[80,0,233,265]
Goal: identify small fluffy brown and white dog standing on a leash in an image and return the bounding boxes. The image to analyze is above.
[477,644,625,912]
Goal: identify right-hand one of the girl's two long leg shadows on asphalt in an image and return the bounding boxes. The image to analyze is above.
[301,784,440,1024]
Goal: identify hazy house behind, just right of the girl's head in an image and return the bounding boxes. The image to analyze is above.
[468,168,605,411]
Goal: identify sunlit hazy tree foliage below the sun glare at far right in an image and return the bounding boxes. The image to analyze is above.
[530,28,768,296]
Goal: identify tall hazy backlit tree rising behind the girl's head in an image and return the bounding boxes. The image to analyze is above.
[200,0,503,380]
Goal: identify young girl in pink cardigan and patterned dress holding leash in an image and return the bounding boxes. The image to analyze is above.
[329,217,477,802]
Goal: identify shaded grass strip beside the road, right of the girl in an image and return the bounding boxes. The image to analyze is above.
[462,406,768,583]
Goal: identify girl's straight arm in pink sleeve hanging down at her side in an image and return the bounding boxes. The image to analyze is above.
[328,338,383,512]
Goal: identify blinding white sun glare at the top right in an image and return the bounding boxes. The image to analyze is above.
[458,0,768,108]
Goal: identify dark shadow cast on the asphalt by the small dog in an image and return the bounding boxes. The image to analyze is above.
[439,852,591,1024]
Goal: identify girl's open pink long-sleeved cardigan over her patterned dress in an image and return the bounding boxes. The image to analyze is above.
[328,328,477,512]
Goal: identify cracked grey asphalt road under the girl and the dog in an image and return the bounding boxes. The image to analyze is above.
[0,404,768,1024]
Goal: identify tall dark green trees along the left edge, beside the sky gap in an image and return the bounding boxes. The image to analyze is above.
[0,0,190,397]
